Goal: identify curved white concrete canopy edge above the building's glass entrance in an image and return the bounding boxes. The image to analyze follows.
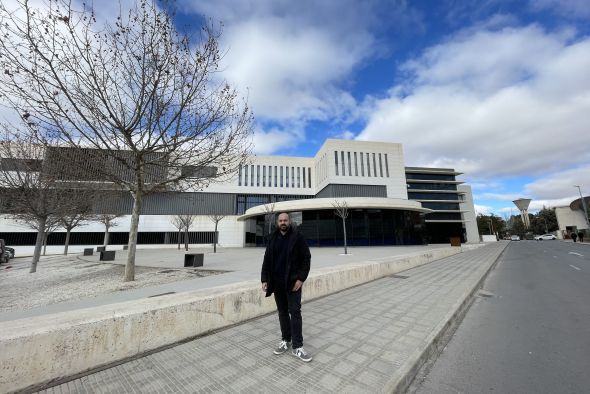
[238,197,432,221]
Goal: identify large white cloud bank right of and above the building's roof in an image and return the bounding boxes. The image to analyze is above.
[358,25,590,179]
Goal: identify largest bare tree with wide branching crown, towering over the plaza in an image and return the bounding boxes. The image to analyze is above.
[0,0,252,281]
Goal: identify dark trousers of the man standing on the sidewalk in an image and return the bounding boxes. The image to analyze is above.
[274,281,303,349]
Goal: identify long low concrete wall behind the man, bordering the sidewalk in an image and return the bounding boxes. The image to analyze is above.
[0,247,461,392]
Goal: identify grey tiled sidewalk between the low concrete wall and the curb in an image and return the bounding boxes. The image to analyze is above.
[42,242,508,393]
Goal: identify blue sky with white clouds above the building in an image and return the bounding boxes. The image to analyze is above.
[8,0,590,215]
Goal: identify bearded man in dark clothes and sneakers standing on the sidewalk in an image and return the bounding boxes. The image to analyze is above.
[261,212,311,362]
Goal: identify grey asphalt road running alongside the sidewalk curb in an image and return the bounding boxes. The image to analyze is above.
[409,241,590,394]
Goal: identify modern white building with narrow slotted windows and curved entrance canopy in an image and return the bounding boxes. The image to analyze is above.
[0,139,479,247]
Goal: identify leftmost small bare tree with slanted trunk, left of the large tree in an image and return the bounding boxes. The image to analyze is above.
[0,131,73,273]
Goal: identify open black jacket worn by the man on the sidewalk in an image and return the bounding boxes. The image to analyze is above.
[260,227,311,297]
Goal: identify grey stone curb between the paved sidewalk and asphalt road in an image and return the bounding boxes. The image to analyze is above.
[382,243,509,393]
